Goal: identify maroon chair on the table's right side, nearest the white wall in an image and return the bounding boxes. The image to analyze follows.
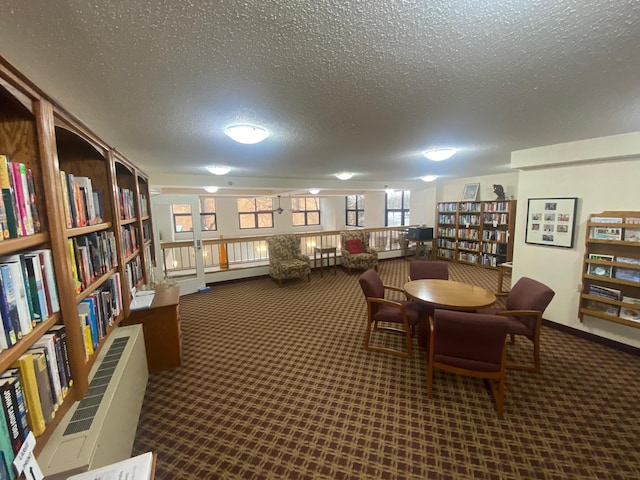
[478,277,555,372]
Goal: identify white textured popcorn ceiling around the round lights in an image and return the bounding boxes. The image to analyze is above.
[0,0,640,187]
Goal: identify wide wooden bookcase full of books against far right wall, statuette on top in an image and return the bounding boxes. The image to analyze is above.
[436,200,516,267]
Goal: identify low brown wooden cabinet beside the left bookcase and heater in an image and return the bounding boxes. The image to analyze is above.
[122,286,182,372]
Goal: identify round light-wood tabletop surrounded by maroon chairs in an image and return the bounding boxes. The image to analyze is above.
[404,280,496,312]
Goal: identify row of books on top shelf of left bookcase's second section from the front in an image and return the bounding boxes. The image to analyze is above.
[60,170,104,228]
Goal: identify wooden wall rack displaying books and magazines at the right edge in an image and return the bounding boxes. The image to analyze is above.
[579,211,640,328]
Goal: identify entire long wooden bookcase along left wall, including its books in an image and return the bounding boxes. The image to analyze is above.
[0,51,152,462]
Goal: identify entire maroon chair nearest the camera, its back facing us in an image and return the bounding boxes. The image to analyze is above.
[427,309,509,415]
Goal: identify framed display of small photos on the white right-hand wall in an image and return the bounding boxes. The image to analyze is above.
[525,197,578,248]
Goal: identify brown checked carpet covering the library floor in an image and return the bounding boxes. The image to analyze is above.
[133,259,640,480]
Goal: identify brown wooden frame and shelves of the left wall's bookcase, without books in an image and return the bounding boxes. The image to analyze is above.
[0,57,154,454]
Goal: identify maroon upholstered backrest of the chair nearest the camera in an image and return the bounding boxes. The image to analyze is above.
[433,309,509,372]
